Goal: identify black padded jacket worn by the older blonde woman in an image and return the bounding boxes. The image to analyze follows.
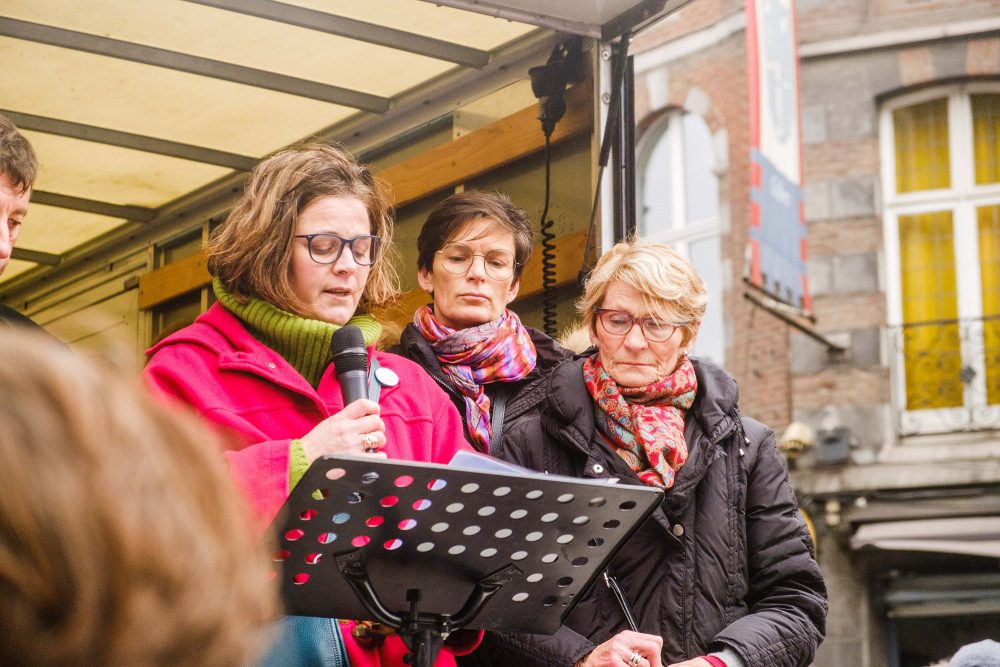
[483,358,827,667]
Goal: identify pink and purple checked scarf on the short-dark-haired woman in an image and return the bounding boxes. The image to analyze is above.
[413,306,538,452]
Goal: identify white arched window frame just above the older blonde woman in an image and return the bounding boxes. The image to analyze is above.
[636,107,726,365]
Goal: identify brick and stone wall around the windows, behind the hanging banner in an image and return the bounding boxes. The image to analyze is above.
[634,0,1000,667]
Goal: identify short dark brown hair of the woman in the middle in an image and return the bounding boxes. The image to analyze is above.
[417,190,535,280]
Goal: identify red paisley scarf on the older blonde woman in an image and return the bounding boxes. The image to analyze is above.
[583,354,698,489]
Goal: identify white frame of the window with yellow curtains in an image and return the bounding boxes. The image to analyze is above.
[879,82,1000,436]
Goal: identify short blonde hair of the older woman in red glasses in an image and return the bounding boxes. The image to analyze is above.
[577,237,708,345]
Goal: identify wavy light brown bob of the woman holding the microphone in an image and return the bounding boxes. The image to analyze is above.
[207,144,399,316]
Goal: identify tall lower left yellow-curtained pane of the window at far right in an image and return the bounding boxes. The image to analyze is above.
[899,211,964,410]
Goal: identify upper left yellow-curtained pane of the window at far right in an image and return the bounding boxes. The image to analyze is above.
[892,98,951,194]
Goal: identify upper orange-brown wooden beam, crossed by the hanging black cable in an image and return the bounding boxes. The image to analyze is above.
[379,79,594,207]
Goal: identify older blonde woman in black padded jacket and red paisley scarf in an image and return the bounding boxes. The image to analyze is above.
[486,240,827,667]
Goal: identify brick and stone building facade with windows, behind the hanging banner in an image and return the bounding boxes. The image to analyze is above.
[632,0,1000,667]
